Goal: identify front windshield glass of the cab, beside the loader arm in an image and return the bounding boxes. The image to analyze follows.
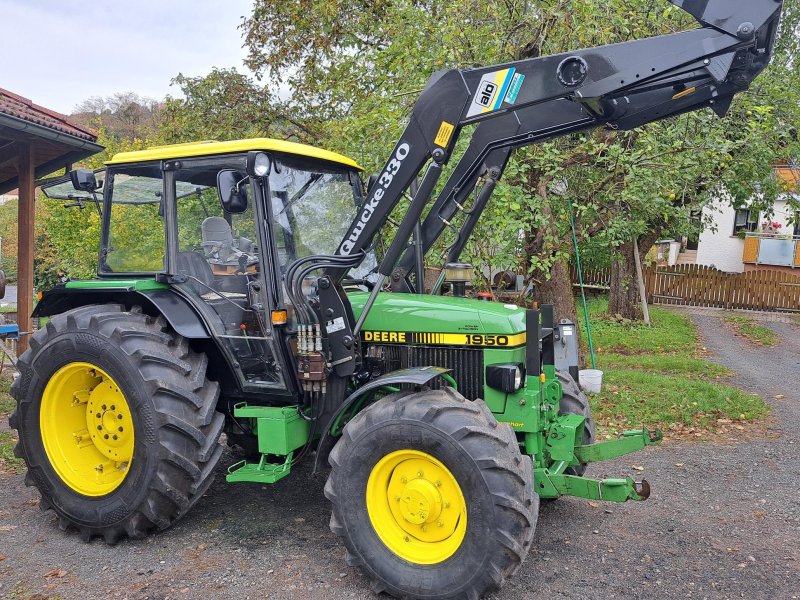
[269,157,375,273]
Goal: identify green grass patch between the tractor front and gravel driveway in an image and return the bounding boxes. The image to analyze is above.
[579,299,769,435]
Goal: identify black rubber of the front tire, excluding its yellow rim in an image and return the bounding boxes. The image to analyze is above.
[325,388,539,600]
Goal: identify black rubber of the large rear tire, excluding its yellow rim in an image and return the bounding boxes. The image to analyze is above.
[10,305,224,544]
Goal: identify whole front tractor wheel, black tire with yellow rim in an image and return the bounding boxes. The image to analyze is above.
[325,388,539,600]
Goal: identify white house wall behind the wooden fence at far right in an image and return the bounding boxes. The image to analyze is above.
[697,198,794,273]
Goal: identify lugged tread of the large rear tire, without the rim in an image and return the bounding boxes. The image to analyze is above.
[11,304,224,544]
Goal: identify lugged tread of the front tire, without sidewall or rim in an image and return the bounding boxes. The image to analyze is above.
[325,388,539,600]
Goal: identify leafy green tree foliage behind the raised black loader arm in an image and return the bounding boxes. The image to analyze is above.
[243,0,800,318]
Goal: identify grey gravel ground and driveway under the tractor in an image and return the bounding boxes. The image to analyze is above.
[0,316,800,600]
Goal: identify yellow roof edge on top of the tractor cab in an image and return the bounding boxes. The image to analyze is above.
[106,138,364,171]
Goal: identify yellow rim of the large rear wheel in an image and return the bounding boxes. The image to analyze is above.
[39,362,134,496]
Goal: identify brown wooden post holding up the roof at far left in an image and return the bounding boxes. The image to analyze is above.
[17,144,35,354]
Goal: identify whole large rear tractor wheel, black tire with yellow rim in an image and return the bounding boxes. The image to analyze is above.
[10,305,224,544]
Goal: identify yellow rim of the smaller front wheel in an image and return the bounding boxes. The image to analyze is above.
[367,450,467,565]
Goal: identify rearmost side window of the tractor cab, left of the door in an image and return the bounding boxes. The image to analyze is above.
[100,165,166,273]
